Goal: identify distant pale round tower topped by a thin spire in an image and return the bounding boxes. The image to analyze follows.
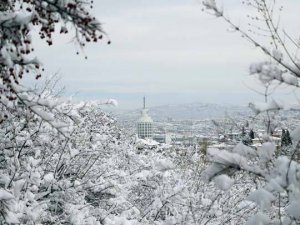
[137,97,153,139]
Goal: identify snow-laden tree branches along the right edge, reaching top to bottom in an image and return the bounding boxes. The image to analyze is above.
[203,0,300,225]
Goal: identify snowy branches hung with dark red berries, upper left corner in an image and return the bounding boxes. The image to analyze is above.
[0,0,104,125]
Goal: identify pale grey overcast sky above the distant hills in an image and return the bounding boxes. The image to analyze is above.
[29,0,300,108]
